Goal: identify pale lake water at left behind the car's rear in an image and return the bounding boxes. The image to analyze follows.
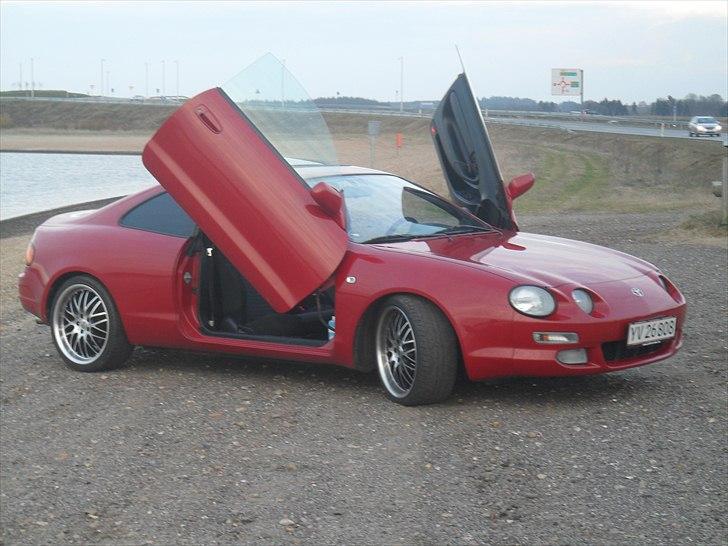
[0,152,156,220]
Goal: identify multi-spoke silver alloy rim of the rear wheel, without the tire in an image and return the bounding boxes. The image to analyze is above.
[52,284,109,365]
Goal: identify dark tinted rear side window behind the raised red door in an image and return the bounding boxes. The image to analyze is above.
[120,192,195,238]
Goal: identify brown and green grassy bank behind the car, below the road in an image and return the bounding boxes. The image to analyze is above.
[0,101,724,221]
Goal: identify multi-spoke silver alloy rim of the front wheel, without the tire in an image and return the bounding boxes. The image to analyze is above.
[376,305,417,398]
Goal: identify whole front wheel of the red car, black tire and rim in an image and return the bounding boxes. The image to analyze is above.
[374,296,458,406]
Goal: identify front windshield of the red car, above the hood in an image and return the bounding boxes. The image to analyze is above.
[306,174,492,243]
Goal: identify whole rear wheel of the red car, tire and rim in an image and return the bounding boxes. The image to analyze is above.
[50,275,134,372]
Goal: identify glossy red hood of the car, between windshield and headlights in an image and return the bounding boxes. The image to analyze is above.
[378,232,655,287]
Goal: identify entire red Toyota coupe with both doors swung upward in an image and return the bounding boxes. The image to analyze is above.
[19,60,685,405]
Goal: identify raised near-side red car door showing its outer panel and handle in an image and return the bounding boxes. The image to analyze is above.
[142,88,348,313]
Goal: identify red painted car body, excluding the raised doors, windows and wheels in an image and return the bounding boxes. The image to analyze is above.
[20,188,685,380]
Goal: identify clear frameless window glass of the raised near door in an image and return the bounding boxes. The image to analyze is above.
[222,53,339,165]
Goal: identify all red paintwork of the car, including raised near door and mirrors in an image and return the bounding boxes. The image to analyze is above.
[19,90,685,380]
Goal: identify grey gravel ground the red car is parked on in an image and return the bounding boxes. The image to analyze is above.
[0,206,728,544]
